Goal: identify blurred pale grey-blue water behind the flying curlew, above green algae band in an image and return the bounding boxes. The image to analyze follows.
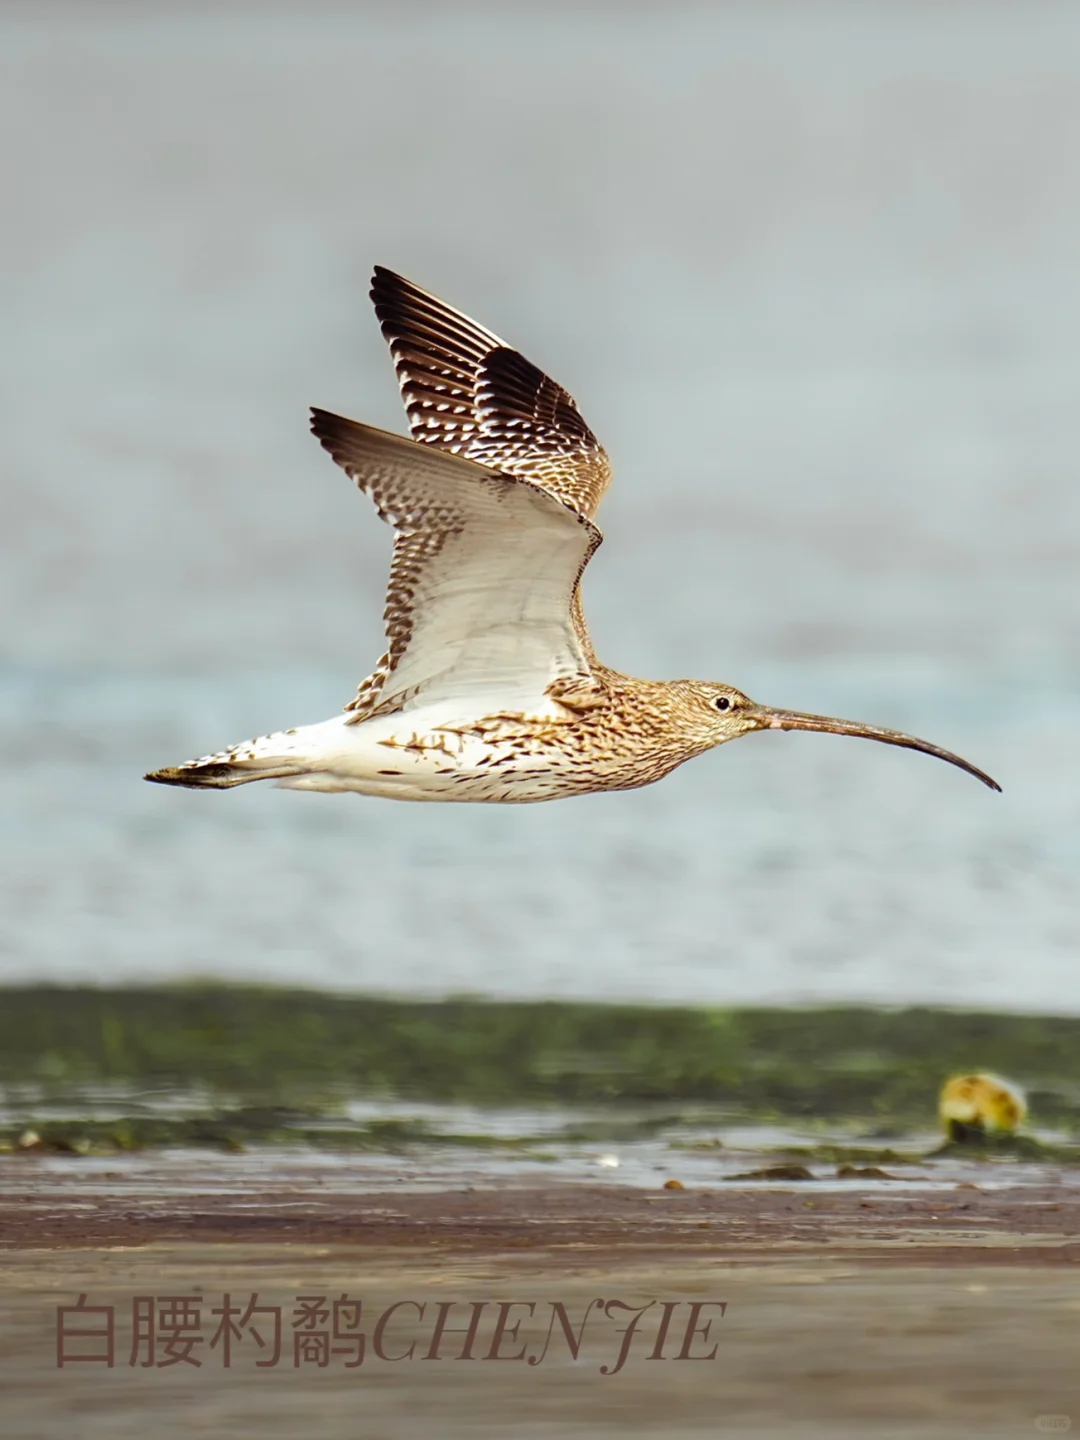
[0,0,1080,1011]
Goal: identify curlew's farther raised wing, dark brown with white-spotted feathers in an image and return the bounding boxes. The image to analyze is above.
[372,265,611,516]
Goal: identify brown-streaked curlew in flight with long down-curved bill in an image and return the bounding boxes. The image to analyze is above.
[145,266,1001,804]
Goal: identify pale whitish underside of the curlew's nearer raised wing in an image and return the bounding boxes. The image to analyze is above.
[311,410,600,719]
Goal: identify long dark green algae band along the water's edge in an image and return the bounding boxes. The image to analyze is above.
[0,985,1080,1128]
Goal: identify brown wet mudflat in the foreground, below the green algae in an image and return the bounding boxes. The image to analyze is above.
[0,1152,1080,1440]
